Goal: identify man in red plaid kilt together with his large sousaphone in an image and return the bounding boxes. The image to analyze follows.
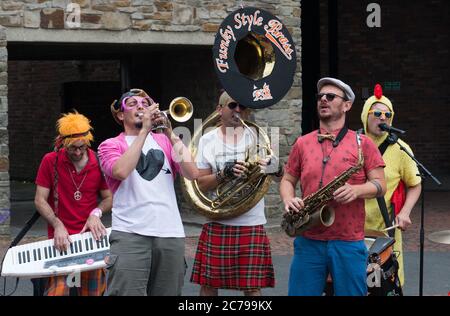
[184,8,296,295]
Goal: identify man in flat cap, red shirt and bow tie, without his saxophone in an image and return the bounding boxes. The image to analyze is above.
[280,77,386,296]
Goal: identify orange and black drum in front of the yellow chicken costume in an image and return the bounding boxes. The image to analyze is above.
[324,233,403,296]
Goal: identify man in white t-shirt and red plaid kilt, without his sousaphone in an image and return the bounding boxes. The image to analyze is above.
[191,92,282,296]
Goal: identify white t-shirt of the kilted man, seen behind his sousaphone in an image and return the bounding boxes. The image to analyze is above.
[197,128,267,226]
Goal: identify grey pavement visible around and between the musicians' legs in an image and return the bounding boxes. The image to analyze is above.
[0,175,450,296]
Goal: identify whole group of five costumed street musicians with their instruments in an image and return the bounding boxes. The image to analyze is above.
[2,8,421,296]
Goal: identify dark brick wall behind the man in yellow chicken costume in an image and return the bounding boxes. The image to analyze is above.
[321,0,450,175]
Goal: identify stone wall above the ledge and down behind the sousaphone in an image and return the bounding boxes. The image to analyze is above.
[0,0,302,222]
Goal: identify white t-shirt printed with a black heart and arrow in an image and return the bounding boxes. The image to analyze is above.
[112,134,185,237]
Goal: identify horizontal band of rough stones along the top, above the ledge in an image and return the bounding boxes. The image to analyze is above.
[0,0,300,32]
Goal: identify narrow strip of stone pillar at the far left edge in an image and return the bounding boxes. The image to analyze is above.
[0,26,10,235]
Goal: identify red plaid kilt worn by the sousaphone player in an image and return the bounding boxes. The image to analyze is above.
[191,223,275,291]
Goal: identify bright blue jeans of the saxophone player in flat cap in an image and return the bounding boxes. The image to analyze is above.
[288,237,368,296]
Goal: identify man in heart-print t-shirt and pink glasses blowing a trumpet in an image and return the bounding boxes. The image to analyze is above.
[98,89,198,296]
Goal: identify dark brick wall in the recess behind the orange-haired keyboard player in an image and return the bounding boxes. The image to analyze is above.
[8,61,120,181]
